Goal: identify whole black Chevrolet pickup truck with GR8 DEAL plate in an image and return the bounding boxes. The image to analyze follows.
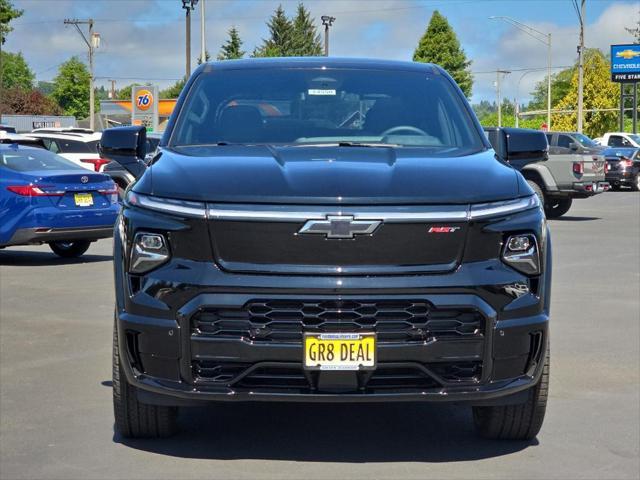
[101,58,551,439]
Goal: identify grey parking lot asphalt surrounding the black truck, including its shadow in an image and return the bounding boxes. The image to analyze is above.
[0,192,640,479]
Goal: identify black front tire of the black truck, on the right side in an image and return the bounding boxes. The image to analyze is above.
[473,351,549,440]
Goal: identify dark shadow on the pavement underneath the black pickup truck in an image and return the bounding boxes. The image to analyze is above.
[114,403,538,463]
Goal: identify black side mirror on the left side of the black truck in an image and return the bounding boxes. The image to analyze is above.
[98,126,147,178]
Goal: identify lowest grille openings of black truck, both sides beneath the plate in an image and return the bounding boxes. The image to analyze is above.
[192,360,481,393]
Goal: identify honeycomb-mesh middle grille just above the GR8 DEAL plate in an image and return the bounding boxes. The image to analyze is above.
[192,300,484,343]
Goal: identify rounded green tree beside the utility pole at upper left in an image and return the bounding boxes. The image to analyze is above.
[51,57,99,119]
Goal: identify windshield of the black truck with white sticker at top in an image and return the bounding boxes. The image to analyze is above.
[169,68,485,156]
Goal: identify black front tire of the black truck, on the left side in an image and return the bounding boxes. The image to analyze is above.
[113,321,178,438]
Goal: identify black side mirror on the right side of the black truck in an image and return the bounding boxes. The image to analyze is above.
[488,127,549,170]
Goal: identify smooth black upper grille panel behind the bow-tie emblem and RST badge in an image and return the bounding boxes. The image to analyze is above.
[210,218,468,275]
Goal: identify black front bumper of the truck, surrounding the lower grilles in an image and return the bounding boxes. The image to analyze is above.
[116,261,550,405]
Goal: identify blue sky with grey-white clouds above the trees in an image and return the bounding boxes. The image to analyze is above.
[3,0,640,102]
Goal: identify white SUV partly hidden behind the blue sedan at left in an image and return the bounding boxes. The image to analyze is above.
[28,128,109,172]
